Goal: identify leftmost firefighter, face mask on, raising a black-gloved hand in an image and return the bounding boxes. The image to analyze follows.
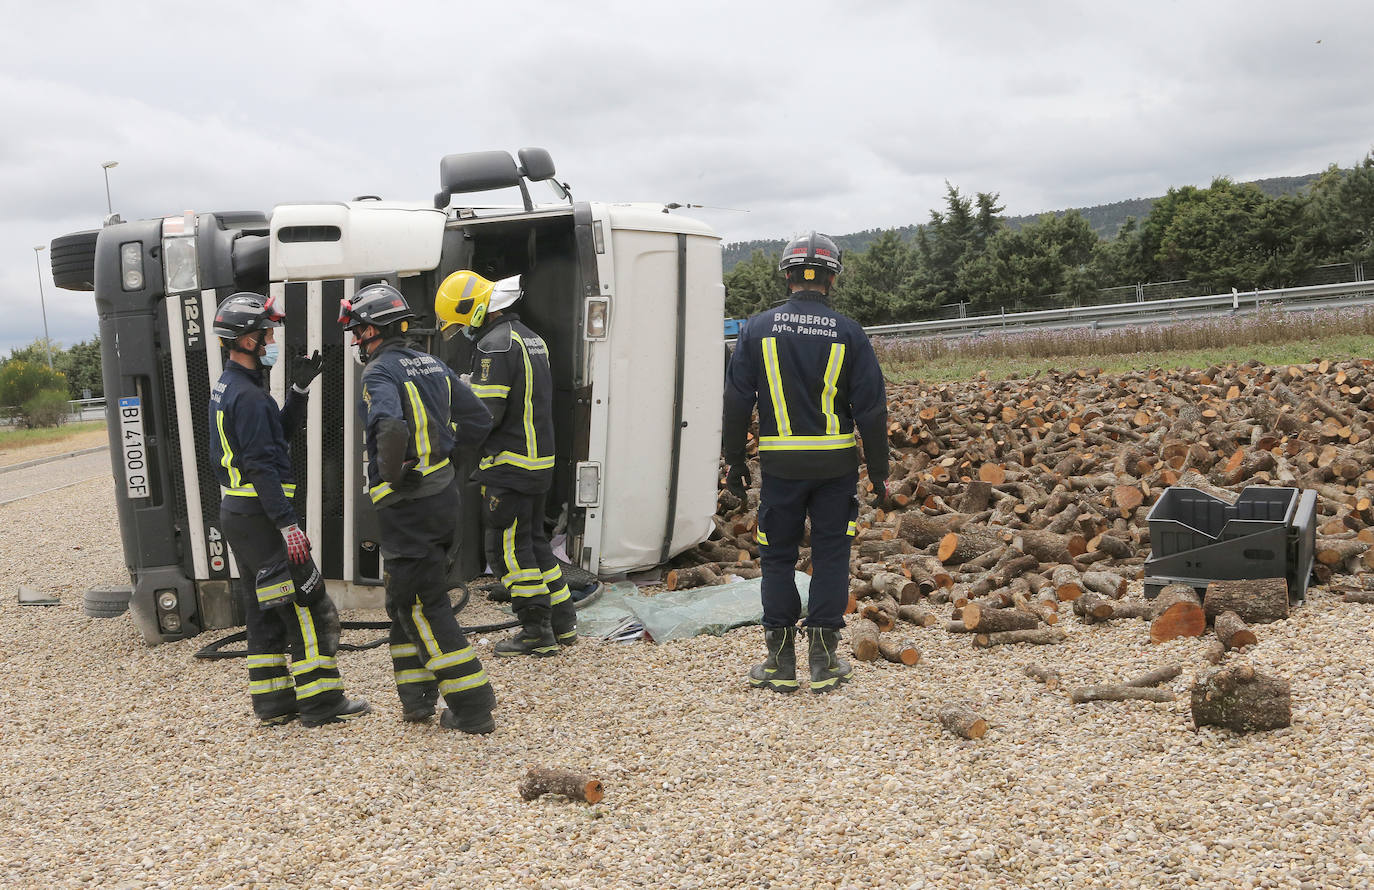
[210,294,371,727]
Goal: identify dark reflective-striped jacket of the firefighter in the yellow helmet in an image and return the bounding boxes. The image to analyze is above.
[473,309,554,494]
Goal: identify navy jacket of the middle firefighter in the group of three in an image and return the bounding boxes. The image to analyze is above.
[359,339,492,507]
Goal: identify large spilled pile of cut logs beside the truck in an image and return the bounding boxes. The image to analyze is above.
[666,360,1374,725]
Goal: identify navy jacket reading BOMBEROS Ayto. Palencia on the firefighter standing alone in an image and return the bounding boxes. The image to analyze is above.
[724,291,888,483]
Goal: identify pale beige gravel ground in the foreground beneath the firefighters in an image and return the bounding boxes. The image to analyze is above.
[0,442,1374,889]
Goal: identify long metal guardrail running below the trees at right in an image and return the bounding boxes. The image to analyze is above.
[864,280,1374,336]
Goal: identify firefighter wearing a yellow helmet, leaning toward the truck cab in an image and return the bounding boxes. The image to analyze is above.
[434,271,577,657]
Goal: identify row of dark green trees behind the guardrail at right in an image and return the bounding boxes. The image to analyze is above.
[725,154,1374,324]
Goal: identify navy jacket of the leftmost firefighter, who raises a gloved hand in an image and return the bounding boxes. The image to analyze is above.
[210,361,306,529]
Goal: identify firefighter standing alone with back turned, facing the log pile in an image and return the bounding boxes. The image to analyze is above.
[724,232,888,692]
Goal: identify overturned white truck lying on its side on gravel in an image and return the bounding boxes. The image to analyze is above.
[54,148,724,643]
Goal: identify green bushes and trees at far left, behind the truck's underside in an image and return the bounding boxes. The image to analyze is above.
[0,336,104,427]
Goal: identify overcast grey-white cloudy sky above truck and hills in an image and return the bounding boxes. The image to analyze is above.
[0,0,1374,354]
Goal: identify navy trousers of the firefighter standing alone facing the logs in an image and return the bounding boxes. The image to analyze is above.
[758,471,859,629]
